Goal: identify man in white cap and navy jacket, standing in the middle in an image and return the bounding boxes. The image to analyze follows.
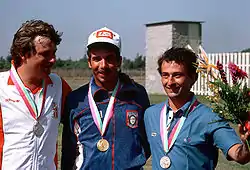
[62,27,150,170]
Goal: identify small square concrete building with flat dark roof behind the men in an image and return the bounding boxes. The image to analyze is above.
[145,21,202,94]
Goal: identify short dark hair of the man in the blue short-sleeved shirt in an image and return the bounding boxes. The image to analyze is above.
[157,47,198,77]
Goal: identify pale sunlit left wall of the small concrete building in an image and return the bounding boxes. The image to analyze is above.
[145,24,172,94]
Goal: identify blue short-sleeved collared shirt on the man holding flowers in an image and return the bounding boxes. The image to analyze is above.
[144,96,241,170]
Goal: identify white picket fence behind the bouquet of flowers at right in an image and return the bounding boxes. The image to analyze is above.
[192,53,250,95]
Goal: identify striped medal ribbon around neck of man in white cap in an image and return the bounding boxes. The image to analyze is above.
[88,78,120,136]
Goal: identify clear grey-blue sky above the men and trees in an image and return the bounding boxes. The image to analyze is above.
[0,0,250,59]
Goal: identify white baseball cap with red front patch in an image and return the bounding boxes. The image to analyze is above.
[87,27,121,50]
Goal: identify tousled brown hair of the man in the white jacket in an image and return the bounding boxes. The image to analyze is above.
[10,20,62,66]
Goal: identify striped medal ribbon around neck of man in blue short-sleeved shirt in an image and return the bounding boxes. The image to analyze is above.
[160,97,199,153]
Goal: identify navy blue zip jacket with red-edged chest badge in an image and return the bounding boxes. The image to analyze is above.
[61,76,150,170]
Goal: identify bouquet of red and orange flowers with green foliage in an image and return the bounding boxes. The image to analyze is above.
[197,47,250,131]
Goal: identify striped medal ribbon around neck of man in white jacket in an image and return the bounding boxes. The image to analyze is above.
[10,63,47,120]
